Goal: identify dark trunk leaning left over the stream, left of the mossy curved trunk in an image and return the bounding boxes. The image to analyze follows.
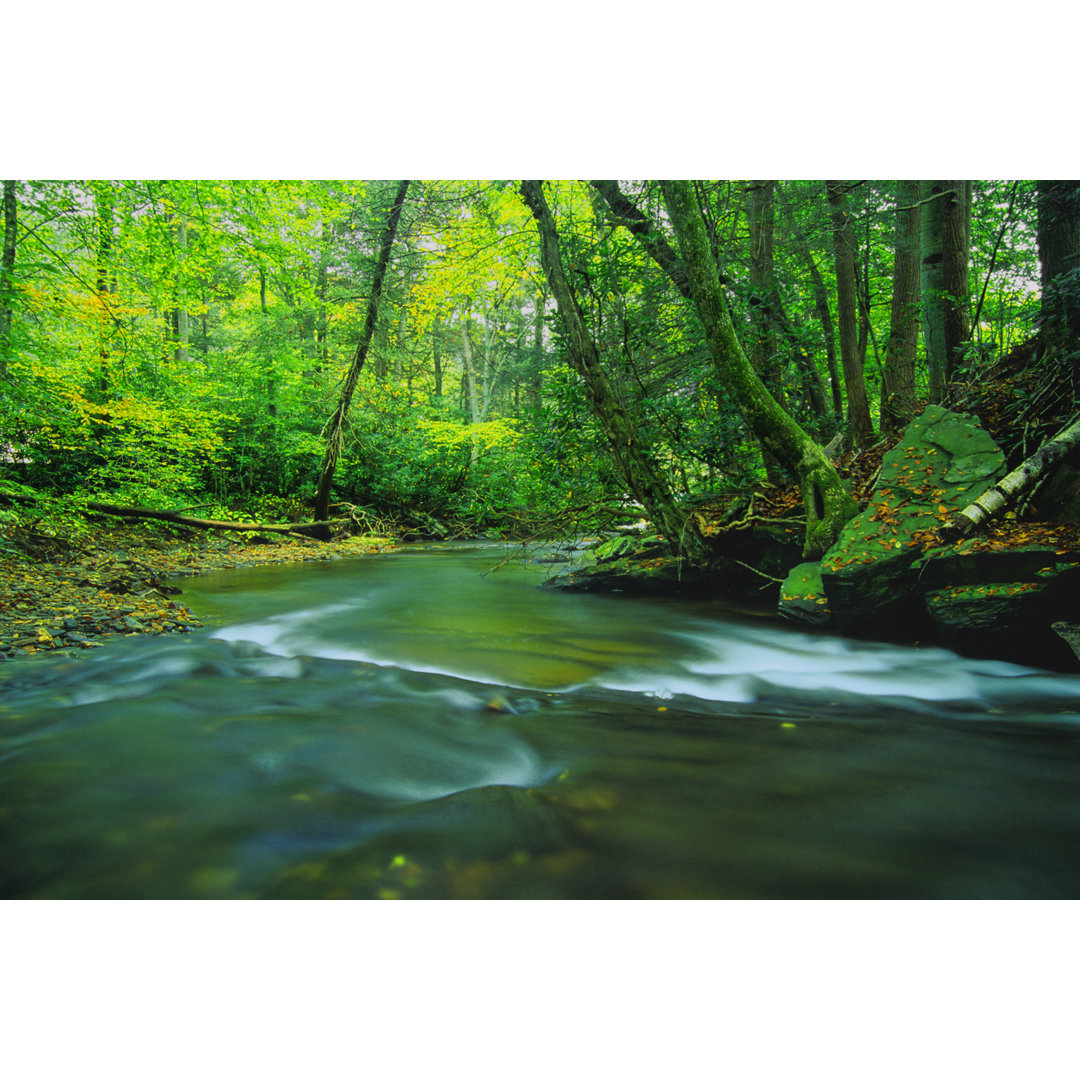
[521,180,711,565]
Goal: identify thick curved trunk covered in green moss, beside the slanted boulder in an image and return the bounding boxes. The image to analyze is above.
[661,180,858,558]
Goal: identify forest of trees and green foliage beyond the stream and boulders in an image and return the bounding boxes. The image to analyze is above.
[0,180,1080,652]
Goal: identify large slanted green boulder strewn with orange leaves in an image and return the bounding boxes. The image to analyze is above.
[812,405,1005,631]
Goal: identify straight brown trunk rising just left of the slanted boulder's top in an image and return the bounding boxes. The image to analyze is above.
[881,180,922,434]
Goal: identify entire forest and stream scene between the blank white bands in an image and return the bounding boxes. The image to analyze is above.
[6,180,1080,900]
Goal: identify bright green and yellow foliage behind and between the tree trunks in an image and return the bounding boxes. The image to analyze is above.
[0,180,1049,540]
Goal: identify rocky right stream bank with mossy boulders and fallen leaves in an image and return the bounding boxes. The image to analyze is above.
[551,405,1080,671]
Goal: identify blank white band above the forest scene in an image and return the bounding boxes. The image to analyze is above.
[12,0,1076,179]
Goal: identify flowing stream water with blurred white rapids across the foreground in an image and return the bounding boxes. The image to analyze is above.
[0,545,1080,899]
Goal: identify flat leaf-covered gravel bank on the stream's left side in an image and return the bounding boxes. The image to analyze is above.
[0,521,394,662]
